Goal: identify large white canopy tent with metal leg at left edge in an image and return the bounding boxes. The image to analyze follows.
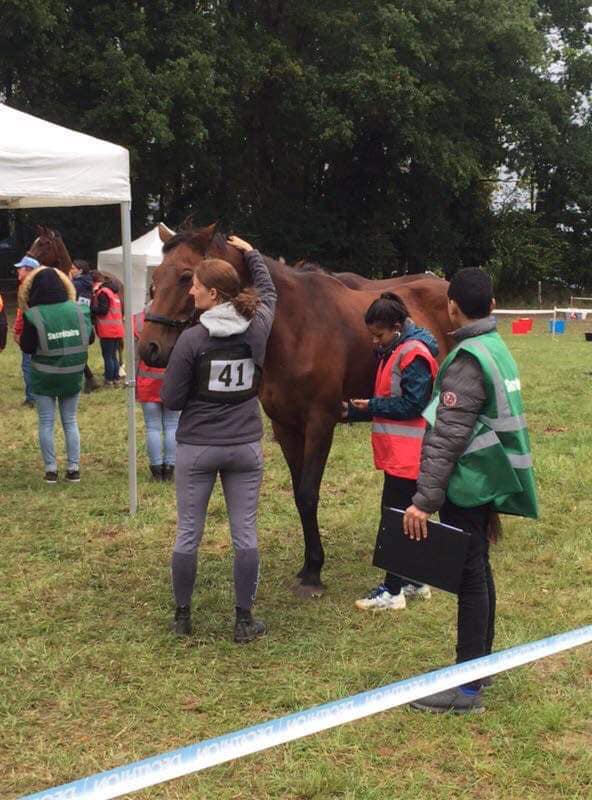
[0,104,138,514]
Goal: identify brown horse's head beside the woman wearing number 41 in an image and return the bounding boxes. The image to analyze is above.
[139,224,242,367]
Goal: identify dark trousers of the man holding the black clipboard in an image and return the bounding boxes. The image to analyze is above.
[440,500,495,663]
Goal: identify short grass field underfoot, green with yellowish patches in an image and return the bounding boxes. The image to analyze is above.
[0,320,592,800]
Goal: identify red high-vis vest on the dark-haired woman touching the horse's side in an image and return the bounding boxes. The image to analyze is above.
[372,339,438,480]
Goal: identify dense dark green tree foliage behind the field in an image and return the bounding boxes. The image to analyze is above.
[0,0,592,287]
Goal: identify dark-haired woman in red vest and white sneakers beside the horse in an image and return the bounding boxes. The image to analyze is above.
[344,292,438,610]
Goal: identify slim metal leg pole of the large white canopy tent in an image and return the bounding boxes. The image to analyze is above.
[121,201,138,514]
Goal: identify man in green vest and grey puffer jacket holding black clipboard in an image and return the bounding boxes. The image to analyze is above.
[404,268,538,713]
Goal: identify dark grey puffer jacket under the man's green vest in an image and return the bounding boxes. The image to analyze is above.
[413,317,496,514]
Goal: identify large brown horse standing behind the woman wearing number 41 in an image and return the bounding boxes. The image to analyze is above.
[139,225,450,599]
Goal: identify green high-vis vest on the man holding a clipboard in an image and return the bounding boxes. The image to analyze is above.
[424,331,538,519]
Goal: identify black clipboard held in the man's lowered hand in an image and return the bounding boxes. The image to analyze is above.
[373,506,471,594]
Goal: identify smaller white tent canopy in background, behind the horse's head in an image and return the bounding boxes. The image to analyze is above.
[97,225,162,314]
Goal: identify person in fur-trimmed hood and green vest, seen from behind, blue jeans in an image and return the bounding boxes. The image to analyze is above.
[19,267,94,483]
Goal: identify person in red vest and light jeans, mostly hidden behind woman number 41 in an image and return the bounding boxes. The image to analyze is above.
[133,304,181,481]
